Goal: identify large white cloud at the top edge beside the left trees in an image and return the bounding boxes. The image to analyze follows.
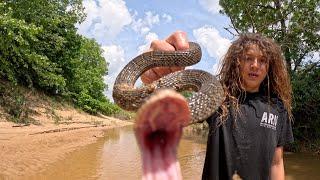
[77,0,132,40]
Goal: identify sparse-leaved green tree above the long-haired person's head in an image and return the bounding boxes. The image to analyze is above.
[220,0,320,73]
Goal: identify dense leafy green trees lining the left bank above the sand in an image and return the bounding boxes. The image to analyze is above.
[0,0,120,118]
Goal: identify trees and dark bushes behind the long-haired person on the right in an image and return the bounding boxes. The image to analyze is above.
[220,0,320,149]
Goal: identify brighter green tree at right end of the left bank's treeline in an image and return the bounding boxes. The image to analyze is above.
[67,38,120,115]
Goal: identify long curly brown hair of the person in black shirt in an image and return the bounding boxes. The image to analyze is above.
[218,33,292,122]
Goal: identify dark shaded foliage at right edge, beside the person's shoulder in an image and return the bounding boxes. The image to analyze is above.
[293,65,320,141]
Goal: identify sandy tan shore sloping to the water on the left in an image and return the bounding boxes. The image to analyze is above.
[0,110,132,180]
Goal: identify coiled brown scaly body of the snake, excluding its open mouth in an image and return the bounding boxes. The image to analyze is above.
[113,42,223,124]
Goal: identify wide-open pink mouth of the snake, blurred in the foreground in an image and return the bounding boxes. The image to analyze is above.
[134,90,191,180]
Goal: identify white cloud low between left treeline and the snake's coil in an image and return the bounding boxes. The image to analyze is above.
[102,45,127,100]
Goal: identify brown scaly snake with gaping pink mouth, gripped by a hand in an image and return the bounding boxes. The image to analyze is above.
[113,42,224,179]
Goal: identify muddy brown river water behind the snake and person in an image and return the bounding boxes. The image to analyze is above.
[26,127,320,180]
